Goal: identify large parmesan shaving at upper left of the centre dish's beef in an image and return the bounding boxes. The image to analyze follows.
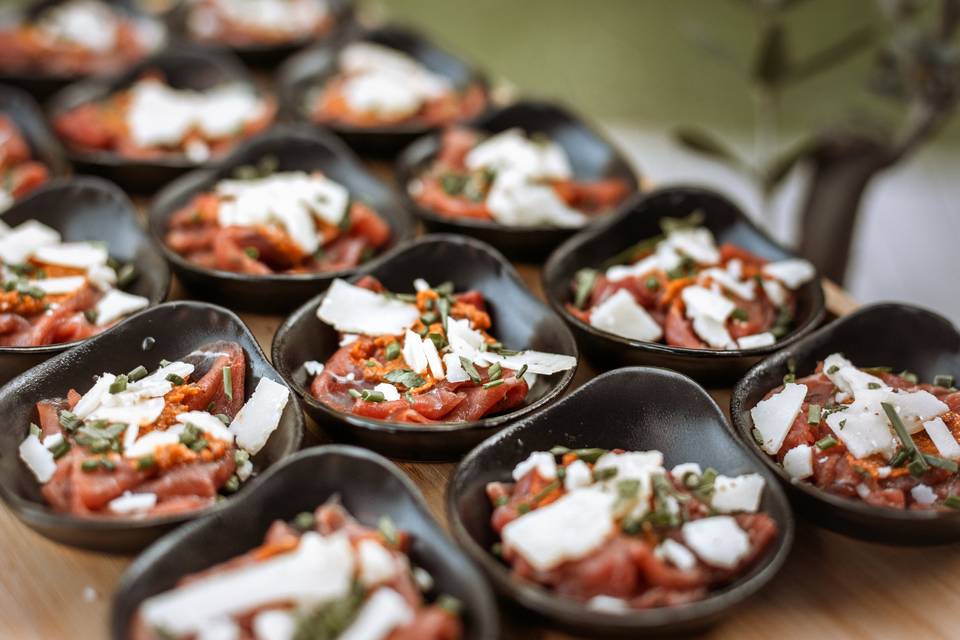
[317,279,420,336]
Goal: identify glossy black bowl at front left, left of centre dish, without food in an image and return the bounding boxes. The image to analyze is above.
[0,302,303,553]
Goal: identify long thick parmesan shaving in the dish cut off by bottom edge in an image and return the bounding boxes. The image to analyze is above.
[141,531,354,636]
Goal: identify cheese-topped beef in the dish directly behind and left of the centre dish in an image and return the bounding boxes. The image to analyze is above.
[166,162,391,275]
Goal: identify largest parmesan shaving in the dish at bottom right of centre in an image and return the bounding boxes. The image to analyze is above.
[502,489,615,571]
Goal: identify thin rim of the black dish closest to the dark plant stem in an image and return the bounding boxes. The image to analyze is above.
[540,186,827,359]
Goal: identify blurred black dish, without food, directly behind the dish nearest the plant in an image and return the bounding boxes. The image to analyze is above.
[396,100,639,262]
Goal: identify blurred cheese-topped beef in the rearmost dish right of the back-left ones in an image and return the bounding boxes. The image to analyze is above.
[307,42,487,128]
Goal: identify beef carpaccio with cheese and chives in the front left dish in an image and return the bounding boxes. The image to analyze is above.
[20,341,289,517]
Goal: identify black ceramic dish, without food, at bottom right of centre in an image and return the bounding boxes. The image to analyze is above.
[447,367,794,637]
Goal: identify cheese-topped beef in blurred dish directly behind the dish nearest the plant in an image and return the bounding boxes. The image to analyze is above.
[407,127,630,227]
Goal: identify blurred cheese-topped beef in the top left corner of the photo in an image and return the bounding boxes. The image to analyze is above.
[0,0,165,76]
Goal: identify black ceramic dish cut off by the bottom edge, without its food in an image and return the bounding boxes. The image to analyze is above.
[110,445,500,640]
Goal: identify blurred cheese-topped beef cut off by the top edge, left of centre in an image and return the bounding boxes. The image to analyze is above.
[187,0,335,47]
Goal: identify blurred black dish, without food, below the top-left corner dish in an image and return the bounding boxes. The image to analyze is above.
[47,44,274,193]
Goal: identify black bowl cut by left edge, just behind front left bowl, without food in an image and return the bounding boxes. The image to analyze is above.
[0,177,170,384]
